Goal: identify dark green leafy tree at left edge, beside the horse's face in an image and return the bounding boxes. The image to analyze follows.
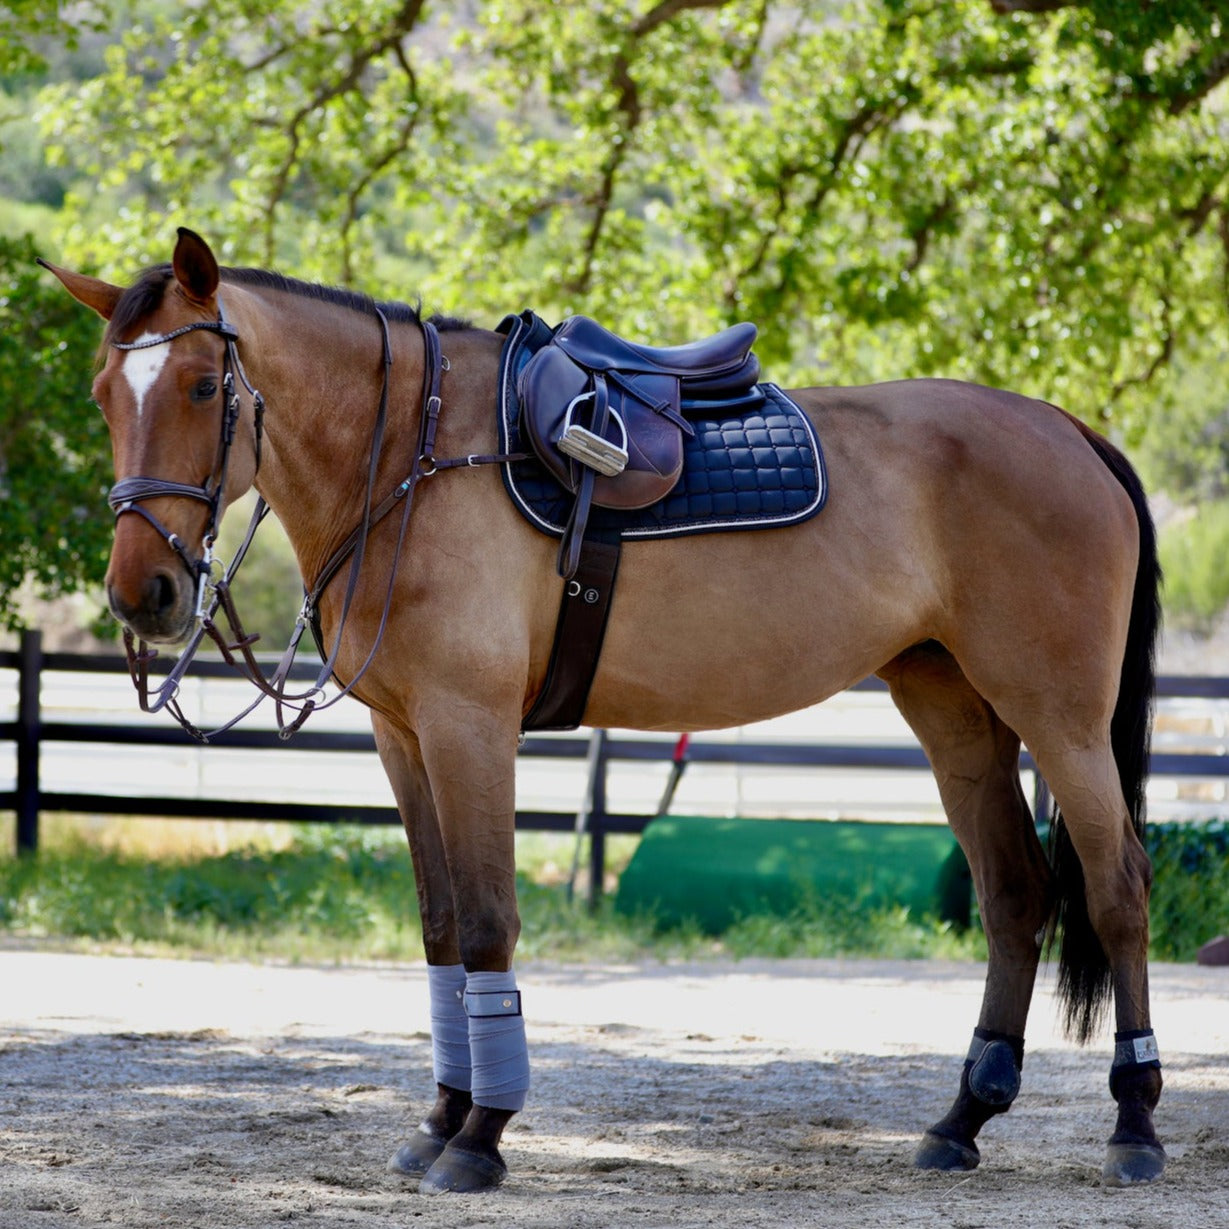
[0,238,111,628]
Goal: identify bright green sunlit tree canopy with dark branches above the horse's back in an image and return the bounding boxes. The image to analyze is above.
[14,0,1229,619]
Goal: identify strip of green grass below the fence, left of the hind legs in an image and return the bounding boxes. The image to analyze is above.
[0,821,984,962]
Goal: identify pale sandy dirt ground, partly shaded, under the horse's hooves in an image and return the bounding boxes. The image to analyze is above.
[0,950,1229,1229]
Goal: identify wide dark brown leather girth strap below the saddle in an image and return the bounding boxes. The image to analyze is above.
[521,535,619,731]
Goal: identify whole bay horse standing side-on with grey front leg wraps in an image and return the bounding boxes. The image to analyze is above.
[40,230,1165,1192]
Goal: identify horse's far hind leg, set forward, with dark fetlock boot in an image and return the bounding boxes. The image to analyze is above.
[880,642,1052,1170]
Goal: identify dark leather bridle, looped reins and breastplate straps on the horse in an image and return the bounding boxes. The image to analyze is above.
[116,301,527,742]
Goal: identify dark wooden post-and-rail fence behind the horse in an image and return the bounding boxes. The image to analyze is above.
[0,630,1229,891]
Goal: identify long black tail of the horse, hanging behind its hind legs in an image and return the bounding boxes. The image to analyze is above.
[1050,412,1161,1043]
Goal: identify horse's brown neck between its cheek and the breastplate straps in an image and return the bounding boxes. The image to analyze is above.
[227,288,435,581]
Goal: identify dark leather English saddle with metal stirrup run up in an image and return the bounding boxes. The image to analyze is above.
[516,316,763,580]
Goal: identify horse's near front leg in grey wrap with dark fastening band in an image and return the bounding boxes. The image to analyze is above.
[408,698,530,1193]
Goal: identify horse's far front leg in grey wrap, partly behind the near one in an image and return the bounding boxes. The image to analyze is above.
[371,714,473,1180]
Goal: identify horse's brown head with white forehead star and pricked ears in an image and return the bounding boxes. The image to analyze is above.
[42,229,261,644]
